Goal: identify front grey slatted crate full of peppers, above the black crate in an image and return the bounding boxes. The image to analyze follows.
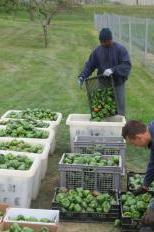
[59,153,122,192]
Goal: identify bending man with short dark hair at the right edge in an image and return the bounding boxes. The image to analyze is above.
[122,120,154,228]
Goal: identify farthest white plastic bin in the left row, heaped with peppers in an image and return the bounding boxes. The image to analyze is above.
[1,110,62,131]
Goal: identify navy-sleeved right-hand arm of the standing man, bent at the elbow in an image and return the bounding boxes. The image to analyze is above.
[112,47,132,77]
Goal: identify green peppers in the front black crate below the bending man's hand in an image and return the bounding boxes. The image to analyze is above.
[121,192,151,219]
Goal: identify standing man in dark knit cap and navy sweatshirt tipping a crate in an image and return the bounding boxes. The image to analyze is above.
[78,28,131,115]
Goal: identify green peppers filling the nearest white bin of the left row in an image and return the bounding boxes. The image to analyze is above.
[0,154,33,170]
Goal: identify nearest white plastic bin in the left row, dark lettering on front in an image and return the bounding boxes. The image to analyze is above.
[0,153,40,208]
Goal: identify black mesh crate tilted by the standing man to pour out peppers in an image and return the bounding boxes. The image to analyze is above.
[85,75,117,120]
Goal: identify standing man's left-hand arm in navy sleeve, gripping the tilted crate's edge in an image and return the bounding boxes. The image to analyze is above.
[79,50,98,80]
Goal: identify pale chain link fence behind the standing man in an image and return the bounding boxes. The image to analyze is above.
[94,14,154,72]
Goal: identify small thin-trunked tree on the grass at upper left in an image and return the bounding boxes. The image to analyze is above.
[32,0,72,48]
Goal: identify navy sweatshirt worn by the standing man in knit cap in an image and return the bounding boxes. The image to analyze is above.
[80,42,131,85]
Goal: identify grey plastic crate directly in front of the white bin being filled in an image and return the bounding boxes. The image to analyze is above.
[73,135,126,175]
